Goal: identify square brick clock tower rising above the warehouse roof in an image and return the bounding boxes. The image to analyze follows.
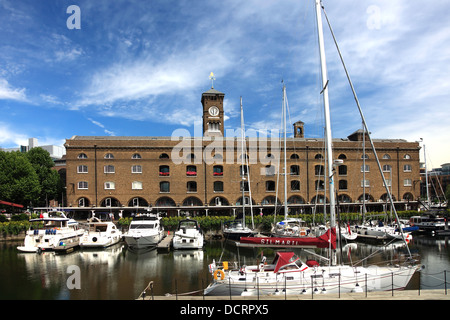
[202,87,225,137]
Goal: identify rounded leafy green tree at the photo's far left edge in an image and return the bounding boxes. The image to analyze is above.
[0,151,41,206]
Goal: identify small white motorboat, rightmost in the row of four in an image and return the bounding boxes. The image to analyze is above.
[172,219,204,249]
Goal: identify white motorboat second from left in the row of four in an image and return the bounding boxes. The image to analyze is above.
[80,213,122,248]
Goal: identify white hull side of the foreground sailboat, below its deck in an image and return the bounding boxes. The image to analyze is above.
[204,266,417,296]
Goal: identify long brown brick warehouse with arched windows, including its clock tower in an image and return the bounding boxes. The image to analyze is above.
[65,88,420,215]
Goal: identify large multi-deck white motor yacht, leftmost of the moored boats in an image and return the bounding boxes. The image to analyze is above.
[17,212,84,252]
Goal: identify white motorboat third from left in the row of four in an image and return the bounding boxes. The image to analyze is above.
[123,214,165,249]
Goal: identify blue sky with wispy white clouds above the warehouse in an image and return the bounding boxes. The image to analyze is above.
[0,0,450,168]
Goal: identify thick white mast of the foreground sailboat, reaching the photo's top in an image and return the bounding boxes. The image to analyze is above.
[316,0,336,228]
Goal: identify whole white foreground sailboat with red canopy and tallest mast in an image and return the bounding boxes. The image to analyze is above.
[204,0,418,295]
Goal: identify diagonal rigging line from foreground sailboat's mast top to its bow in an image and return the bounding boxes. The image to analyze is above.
[322,5,412,258]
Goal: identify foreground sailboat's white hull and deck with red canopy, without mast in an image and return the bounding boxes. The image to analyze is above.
[204,251,418,296]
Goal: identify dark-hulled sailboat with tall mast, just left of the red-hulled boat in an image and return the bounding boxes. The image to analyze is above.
[222,97,256,240]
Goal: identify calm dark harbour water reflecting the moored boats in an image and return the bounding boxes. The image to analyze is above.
[0,235,450,300]
